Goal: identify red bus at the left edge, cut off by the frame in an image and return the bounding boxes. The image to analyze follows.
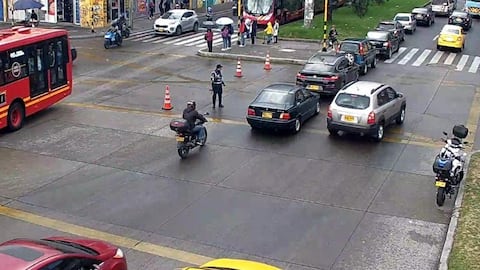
[0,26,73,131]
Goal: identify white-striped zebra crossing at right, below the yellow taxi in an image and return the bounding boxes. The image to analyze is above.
[384,47,480,73]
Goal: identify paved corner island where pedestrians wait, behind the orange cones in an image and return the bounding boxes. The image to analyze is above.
[197,39,322,65]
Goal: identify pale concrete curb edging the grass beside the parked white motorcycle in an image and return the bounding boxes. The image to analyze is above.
[438,150,480,270]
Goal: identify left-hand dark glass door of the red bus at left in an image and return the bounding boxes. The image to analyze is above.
[27,43,48,98]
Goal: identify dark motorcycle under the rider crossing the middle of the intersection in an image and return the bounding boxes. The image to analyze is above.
[170,113,208,159]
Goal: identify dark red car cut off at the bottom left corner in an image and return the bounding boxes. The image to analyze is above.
[0,237,127,270]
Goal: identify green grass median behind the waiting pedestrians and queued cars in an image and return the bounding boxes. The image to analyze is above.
[279,0,428,39]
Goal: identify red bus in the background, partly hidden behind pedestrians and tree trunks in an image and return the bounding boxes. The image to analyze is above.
[243,0,345,26]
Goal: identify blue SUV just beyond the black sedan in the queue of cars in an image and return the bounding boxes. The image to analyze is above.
[338,38,377,75]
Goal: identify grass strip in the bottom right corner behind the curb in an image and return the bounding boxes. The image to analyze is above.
[448,153,480,270]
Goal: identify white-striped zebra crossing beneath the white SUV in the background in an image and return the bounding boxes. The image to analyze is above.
[124,30,238,48]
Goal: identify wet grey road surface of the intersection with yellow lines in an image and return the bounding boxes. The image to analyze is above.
[0,2,480,269]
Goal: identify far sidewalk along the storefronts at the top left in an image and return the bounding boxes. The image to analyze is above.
[0,2,233,39]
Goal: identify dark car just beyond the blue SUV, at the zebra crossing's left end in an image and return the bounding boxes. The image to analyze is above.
[367,31,400,59]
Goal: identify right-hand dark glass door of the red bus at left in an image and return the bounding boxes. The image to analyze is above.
[47,38,68,90]
